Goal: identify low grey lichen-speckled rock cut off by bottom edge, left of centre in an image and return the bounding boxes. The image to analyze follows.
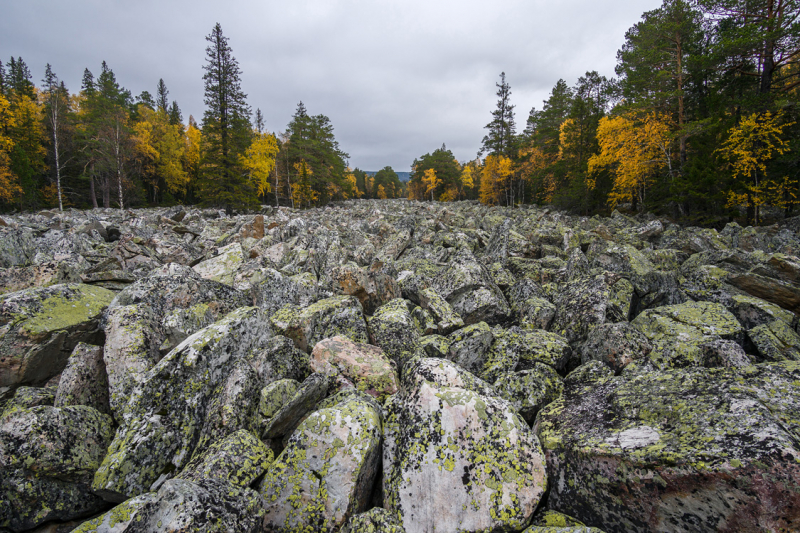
[74,479,264,533]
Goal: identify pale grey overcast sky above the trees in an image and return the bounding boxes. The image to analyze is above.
[0,0,661,171]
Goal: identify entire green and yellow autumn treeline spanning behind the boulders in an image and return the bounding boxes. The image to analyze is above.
[0,0,800,224]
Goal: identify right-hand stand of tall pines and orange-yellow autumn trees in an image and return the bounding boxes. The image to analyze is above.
[409,0,800,224]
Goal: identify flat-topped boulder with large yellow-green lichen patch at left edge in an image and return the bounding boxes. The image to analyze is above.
[0,284,114,387]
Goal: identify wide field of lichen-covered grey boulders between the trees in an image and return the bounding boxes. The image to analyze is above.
[0,200,800,533]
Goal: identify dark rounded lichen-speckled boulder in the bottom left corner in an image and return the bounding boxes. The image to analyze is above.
[0,405,114,531]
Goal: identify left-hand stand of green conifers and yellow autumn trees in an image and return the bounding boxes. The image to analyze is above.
[0,24,402,211]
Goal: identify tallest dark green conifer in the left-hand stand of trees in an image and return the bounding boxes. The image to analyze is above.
[201,23,257,213]
